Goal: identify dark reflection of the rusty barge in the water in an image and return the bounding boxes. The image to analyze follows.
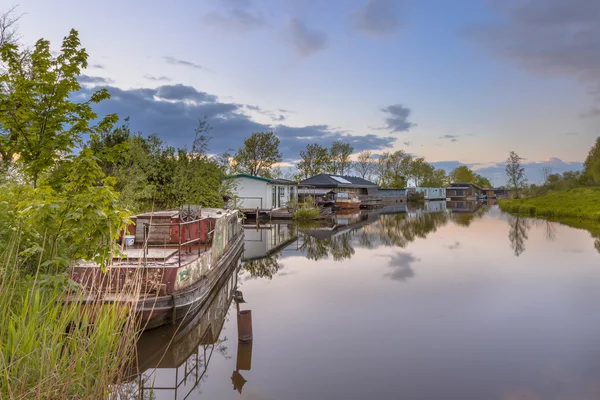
[118,263,243,399]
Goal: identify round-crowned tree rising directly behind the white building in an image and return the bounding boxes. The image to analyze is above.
[234,132,282,176]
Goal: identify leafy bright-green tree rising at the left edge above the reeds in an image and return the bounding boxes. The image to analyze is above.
[0,30,117,187]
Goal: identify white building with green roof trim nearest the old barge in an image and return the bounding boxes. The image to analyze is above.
[225,174,298,211]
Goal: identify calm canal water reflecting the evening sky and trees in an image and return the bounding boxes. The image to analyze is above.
[124,206,600,400]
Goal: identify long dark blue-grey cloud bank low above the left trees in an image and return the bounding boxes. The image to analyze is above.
[75,84,395,161]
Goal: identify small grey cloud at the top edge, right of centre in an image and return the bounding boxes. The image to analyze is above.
[350,0,403,36]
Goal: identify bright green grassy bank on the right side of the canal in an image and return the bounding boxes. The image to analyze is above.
[499,187,600,222]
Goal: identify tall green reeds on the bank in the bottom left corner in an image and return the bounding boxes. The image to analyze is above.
[0,233,141,399]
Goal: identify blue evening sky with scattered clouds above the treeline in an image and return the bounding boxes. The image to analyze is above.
[8,0,600,184]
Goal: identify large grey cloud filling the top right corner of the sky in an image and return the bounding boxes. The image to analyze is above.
[465,0,600,112]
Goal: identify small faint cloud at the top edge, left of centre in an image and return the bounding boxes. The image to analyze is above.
[203,0,266,33]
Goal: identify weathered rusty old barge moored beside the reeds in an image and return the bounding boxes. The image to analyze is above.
[70,206,244,329]
